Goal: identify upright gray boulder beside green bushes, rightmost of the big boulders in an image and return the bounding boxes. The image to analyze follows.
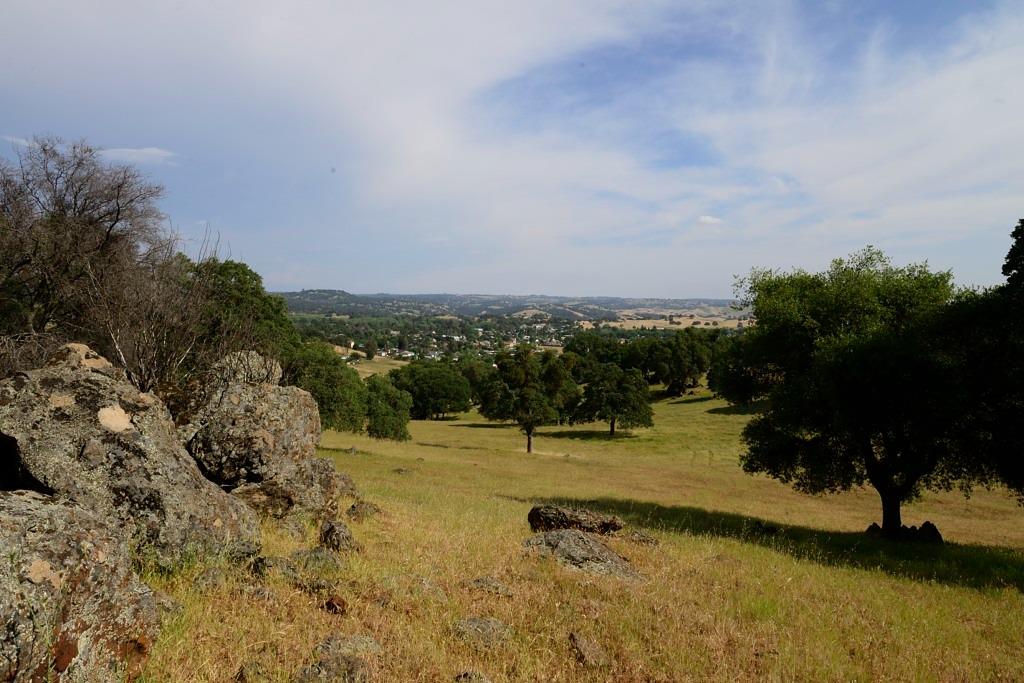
[182,352,355,518]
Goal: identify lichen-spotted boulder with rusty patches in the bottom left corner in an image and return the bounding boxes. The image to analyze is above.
[0,490,160,683]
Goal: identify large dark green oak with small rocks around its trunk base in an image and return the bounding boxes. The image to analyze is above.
[711,248,986,535]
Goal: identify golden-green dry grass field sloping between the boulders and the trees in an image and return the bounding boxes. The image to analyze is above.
[146,394,1024,682]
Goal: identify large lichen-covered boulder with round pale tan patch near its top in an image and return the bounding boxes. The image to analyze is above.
[0,344,259,562]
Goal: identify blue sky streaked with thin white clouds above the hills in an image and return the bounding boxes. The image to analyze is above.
[0,0,1024,297]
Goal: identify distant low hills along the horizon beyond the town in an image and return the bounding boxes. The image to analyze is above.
[278,290,731,321]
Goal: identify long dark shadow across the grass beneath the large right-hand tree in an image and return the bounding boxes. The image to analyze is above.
[527,498,1024,592]
